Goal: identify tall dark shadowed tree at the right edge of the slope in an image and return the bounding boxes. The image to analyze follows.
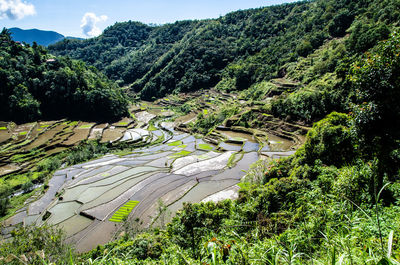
[349,33,400,196]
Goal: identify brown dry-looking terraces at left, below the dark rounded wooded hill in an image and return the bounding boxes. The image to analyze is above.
[0,114,143,176]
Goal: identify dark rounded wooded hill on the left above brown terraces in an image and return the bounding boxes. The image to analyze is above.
[0,29,127,122]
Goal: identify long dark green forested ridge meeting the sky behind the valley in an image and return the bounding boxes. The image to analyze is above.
[50,0,399,99]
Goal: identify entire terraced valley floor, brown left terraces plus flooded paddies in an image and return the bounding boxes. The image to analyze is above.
[0,91,304,252]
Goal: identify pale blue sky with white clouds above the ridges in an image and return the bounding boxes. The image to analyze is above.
[0,0,296,37]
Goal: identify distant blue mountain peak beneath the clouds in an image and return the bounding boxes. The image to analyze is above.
[9,28,79,46]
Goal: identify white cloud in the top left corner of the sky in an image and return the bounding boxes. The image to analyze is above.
[0,0,36,20]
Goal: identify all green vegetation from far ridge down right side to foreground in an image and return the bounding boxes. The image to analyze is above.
[0,0,400,265]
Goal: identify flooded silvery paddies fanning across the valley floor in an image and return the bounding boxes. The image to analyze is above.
[1,109,293,252]
